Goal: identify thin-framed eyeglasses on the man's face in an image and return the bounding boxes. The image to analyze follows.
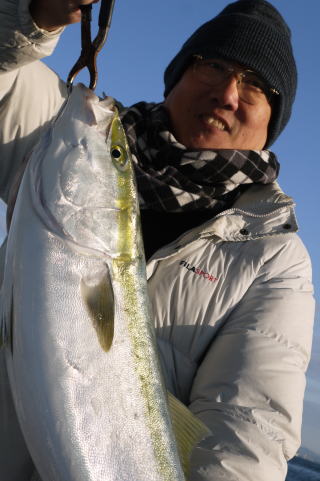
[193,55,279,105]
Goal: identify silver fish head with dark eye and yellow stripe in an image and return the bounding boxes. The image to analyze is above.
[34,86,141,258]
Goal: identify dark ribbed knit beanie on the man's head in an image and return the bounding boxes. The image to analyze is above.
[164,0,297,147]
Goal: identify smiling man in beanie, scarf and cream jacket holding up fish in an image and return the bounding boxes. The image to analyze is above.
[0,0,314,481]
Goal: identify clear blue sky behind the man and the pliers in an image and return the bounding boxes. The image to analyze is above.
[0,0,320,454]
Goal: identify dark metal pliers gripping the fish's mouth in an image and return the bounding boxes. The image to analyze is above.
[67,0,115,90]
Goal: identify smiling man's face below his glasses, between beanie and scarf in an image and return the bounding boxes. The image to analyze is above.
[164,60,271,150]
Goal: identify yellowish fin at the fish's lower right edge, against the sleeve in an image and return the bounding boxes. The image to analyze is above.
[168,391,211,479]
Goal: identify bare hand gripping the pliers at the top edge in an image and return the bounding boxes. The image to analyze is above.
[30,0,99,32]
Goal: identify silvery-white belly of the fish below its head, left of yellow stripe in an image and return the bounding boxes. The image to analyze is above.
[3,218,180,481]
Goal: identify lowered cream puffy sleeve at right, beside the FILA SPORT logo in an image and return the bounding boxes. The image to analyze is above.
[189,236,314,481]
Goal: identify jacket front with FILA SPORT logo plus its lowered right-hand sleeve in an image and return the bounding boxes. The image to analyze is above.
[148,184,314,481]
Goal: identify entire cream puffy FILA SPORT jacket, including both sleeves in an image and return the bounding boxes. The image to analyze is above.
[0,0,314,481]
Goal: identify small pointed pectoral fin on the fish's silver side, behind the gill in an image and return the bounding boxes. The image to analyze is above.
[80,266,114,351]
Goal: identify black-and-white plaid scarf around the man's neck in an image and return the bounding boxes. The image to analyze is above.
[121,102,279,213]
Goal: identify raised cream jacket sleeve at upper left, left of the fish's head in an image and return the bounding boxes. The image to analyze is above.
[0,0,66,202]
